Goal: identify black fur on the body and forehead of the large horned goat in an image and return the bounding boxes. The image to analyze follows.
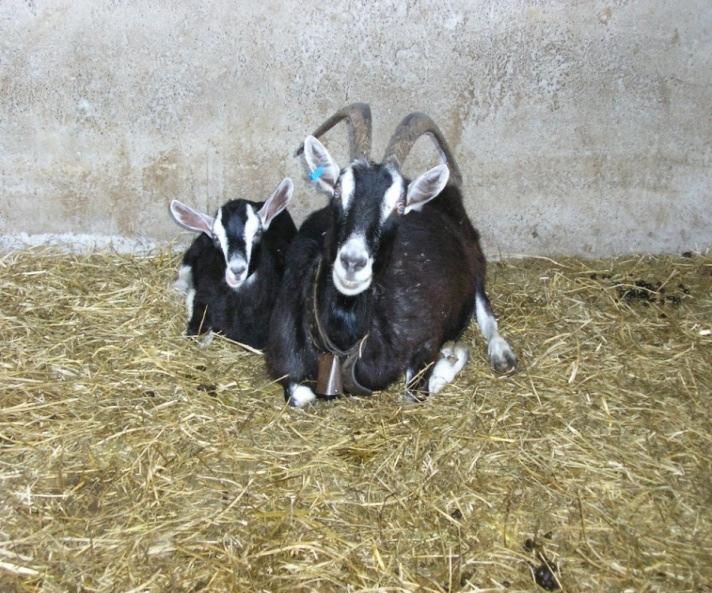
[267,163,485,399]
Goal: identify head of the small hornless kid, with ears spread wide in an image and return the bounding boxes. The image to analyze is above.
[171,178,294,290]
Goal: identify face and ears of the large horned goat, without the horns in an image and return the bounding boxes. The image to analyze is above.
[304,136,449,296]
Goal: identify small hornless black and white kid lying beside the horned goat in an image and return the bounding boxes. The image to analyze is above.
[171,178,296,348]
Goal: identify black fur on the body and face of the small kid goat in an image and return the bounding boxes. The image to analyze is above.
[183,200,296,348]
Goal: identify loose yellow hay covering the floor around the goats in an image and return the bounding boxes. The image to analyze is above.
[0,250,712,593]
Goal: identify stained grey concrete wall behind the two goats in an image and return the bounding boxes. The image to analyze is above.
[0,0,712,256]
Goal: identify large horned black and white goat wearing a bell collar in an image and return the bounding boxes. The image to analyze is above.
[267,103,516,406]
